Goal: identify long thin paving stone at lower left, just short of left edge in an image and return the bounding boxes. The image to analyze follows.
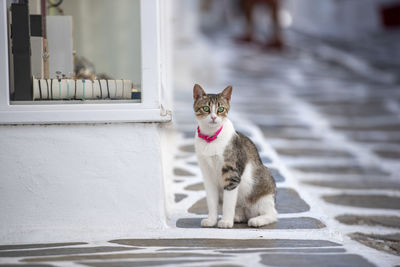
[21,252,229,262]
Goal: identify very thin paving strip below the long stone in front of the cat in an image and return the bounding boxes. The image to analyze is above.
[219,248,346,254]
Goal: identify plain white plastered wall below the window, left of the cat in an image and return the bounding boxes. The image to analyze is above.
[0,123,165,244]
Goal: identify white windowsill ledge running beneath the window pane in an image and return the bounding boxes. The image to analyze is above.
[0,104,171,124]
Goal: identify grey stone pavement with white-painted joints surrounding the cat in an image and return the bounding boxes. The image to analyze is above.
[0,36,400,266]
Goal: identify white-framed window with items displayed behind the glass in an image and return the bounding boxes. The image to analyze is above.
[0,0,170,123]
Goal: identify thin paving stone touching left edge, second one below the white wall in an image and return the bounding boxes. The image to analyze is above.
[0,246,138,257]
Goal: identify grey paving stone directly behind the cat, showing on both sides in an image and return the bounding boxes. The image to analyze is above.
[188,188,310,214]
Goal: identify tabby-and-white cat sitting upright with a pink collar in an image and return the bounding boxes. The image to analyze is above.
[193,84,277,228]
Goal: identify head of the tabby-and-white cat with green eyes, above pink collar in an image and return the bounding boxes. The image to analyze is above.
[193,84,232,128]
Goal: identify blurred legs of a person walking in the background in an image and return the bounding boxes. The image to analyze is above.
[236,0,283,50]
